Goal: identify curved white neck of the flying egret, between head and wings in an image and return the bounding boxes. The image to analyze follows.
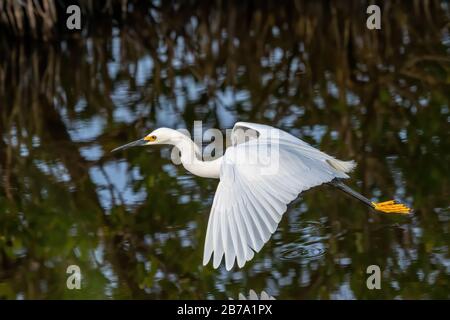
[175,137,222,179]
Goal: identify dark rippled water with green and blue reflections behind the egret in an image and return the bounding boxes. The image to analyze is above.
[0,1,450,299]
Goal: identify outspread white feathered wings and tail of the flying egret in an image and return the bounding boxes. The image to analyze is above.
[203,122,354,270]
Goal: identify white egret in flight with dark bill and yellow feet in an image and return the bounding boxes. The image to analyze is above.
[113,122,411,270]
